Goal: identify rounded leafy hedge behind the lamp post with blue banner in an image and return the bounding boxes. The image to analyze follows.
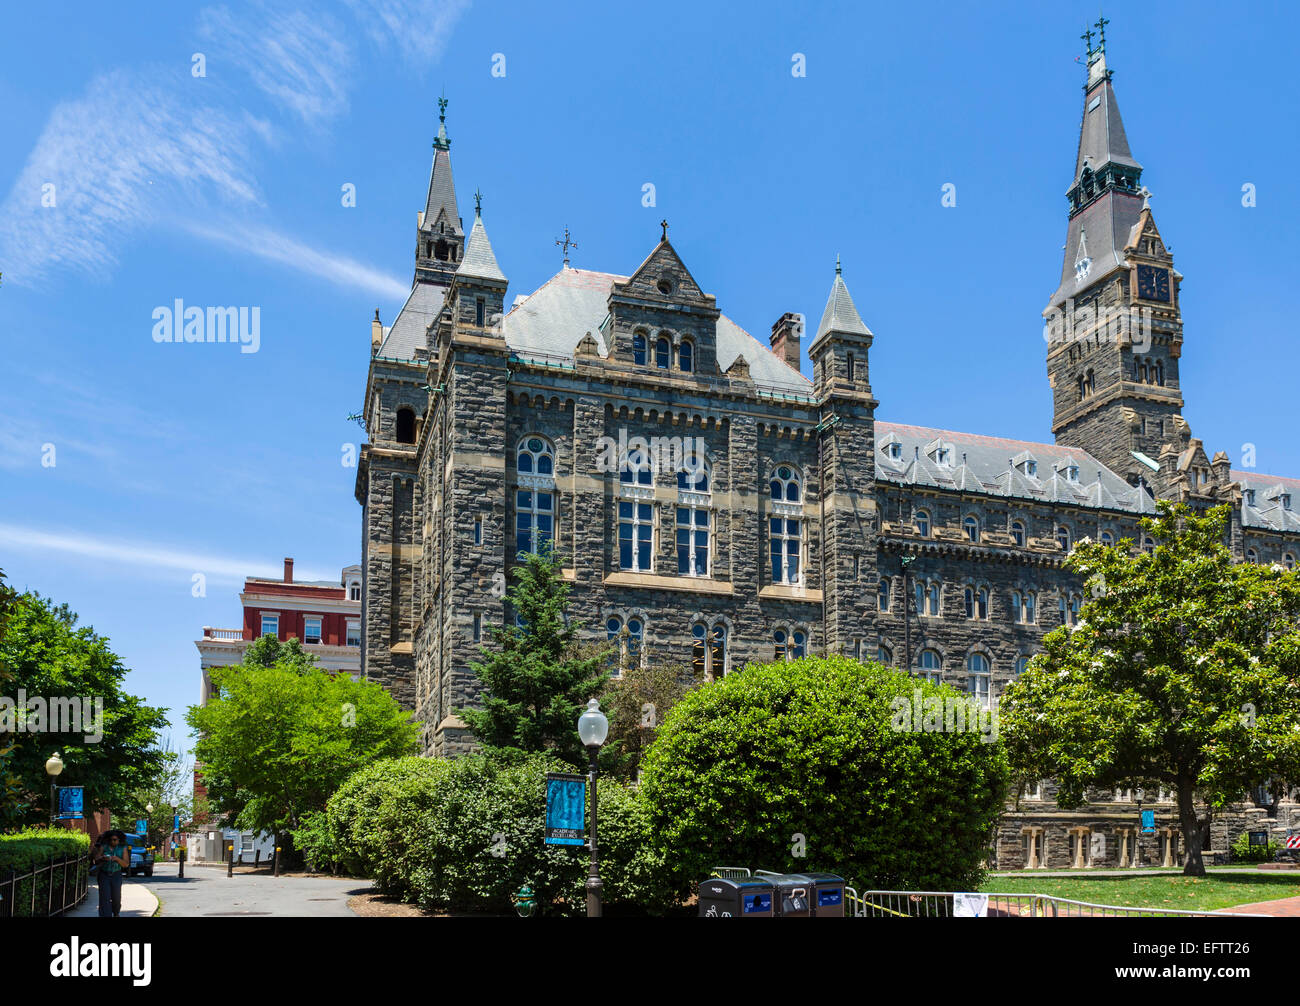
[295,754,673,915]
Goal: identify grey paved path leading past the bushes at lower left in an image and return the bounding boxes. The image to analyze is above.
[138,863,371,918]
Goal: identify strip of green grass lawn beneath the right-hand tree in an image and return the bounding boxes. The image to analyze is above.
[980,871,1300,910]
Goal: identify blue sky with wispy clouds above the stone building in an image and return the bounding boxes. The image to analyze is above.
[0,0,1300,759]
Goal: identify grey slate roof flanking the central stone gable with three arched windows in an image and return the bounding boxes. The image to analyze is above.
[503,269,813,395]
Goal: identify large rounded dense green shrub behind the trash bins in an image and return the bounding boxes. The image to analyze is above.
[641,656,1008,892]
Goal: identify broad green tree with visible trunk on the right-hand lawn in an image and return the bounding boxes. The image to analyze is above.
[1000,502,1300,876]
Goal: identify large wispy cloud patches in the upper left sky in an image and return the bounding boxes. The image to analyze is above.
[0,0,468,296]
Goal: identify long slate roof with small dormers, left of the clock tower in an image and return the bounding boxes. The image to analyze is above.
[876,420,1156,513]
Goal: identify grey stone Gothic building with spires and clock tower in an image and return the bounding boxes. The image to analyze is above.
[356,44,1300,866]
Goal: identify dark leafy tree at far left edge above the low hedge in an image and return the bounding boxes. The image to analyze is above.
[0,593,166,823]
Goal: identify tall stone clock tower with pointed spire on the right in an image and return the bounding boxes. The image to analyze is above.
[1043,25,1187,486]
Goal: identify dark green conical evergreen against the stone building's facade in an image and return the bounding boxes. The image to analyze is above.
[459,551,610,767]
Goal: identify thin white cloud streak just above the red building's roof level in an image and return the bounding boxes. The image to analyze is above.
[0,522,338,582]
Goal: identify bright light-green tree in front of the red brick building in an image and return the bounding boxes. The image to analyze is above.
[186,641,416,838]
